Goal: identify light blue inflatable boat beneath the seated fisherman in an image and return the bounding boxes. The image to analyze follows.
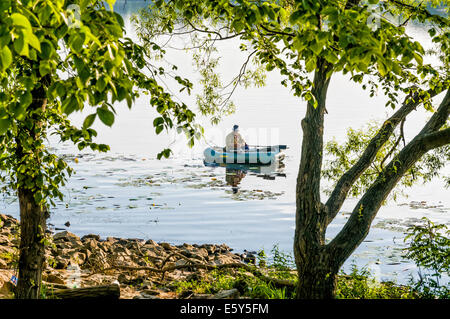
[203,145,287,165]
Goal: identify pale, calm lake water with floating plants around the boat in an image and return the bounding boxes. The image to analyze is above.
[0,1,450,282]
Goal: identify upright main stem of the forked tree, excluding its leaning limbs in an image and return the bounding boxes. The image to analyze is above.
[294,60,337,299]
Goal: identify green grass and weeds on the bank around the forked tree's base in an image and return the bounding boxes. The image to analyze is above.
[174,239,450,299]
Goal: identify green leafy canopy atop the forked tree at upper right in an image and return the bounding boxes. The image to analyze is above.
[139,0,450,111]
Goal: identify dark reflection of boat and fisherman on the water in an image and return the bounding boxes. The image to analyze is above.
[204,161,286,194]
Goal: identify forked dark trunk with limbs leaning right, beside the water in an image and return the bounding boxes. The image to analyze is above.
[294,63,450,299]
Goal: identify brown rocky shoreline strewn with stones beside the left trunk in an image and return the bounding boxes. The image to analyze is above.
[0,214,256,299]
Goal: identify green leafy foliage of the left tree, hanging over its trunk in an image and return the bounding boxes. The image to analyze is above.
[0,0,198,205]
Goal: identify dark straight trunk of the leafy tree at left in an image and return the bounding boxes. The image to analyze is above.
[16,76,50,299]
